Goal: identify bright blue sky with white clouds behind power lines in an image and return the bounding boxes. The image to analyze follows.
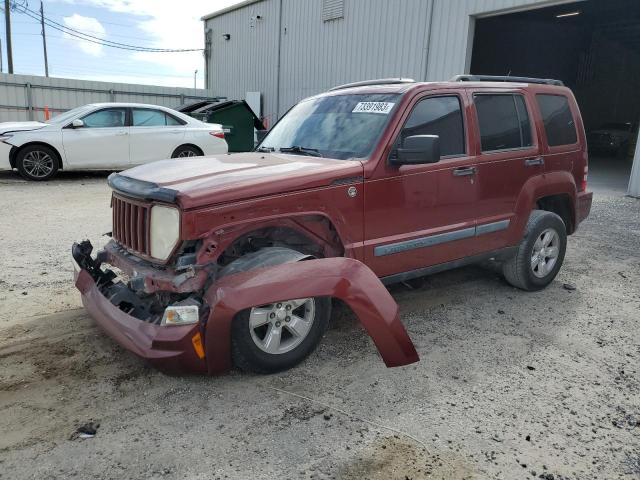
[0,0,245,88]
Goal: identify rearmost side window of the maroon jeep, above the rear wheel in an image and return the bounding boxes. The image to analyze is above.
[536,94,578,147]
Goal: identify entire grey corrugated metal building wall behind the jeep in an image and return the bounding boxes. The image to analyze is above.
[205,0,572,123]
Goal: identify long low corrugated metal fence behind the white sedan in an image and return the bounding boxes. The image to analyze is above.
[0,74,220,122]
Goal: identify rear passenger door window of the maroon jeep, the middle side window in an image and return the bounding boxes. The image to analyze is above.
[473,94,533,152]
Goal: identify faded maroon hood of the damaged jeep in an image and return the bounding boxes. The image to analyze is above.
[109,152,363,209]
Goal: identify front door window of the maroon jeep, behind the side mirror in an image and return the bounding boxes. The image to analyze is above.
[400,96,465,157]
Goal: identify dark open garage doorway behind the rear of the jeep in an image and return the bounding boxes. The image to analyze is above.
[470,0,640,190]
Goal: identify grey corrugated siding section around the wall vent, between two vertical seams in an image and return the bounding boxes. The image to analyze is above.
[280,0,430,112]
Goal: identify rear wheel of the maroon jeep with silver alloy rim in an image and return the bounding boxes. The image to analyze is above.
[502,210,567,291]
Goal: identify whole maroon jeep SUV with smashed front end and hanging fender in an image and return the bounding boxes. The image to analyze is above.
[72,75,592,374]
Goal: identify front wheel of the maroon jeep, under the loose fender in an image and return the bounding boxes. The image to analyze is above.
[231,297,331,373]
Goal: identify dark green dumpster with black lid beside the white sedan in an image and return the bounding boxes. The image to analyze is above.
[201,100,264,152]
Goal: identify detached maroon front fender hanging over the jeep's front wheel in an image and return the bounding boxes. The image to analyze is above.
[205,258,419,374]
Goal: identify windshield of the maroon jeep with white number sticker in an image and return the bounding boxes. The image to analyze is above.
[259,94,399,160]
